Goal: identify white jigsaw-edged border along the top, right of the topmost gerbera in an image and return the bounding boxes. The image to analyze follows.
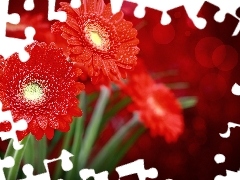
[110,0,240,36]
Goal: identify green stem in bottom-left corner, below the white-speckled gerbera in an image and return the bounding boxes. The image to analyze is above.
[7,135,30,180]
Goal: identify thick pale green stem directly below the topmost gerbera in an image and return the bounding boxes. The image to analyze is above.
[78,86,110,169]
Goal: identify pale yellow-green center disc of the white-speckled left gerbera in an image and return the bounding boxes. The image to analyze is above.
[23,83,43,101]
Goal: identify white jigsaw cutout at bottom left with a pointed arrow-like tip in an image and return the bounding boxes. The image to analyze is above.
[22,149,73,180]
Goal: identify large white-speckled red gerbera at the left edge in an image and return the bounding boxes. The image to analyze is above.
[0,42,84,140]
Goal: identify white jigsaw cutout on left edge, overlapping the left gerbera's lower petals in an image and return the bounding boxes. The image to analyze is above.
[0,102,27,150]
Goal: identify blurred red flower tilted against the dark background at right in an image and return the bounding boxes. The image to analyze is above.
[124,65,183,142]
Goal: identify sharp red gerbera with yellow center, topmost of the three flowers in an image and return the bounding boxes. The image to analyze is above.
[52,0,139,83]
